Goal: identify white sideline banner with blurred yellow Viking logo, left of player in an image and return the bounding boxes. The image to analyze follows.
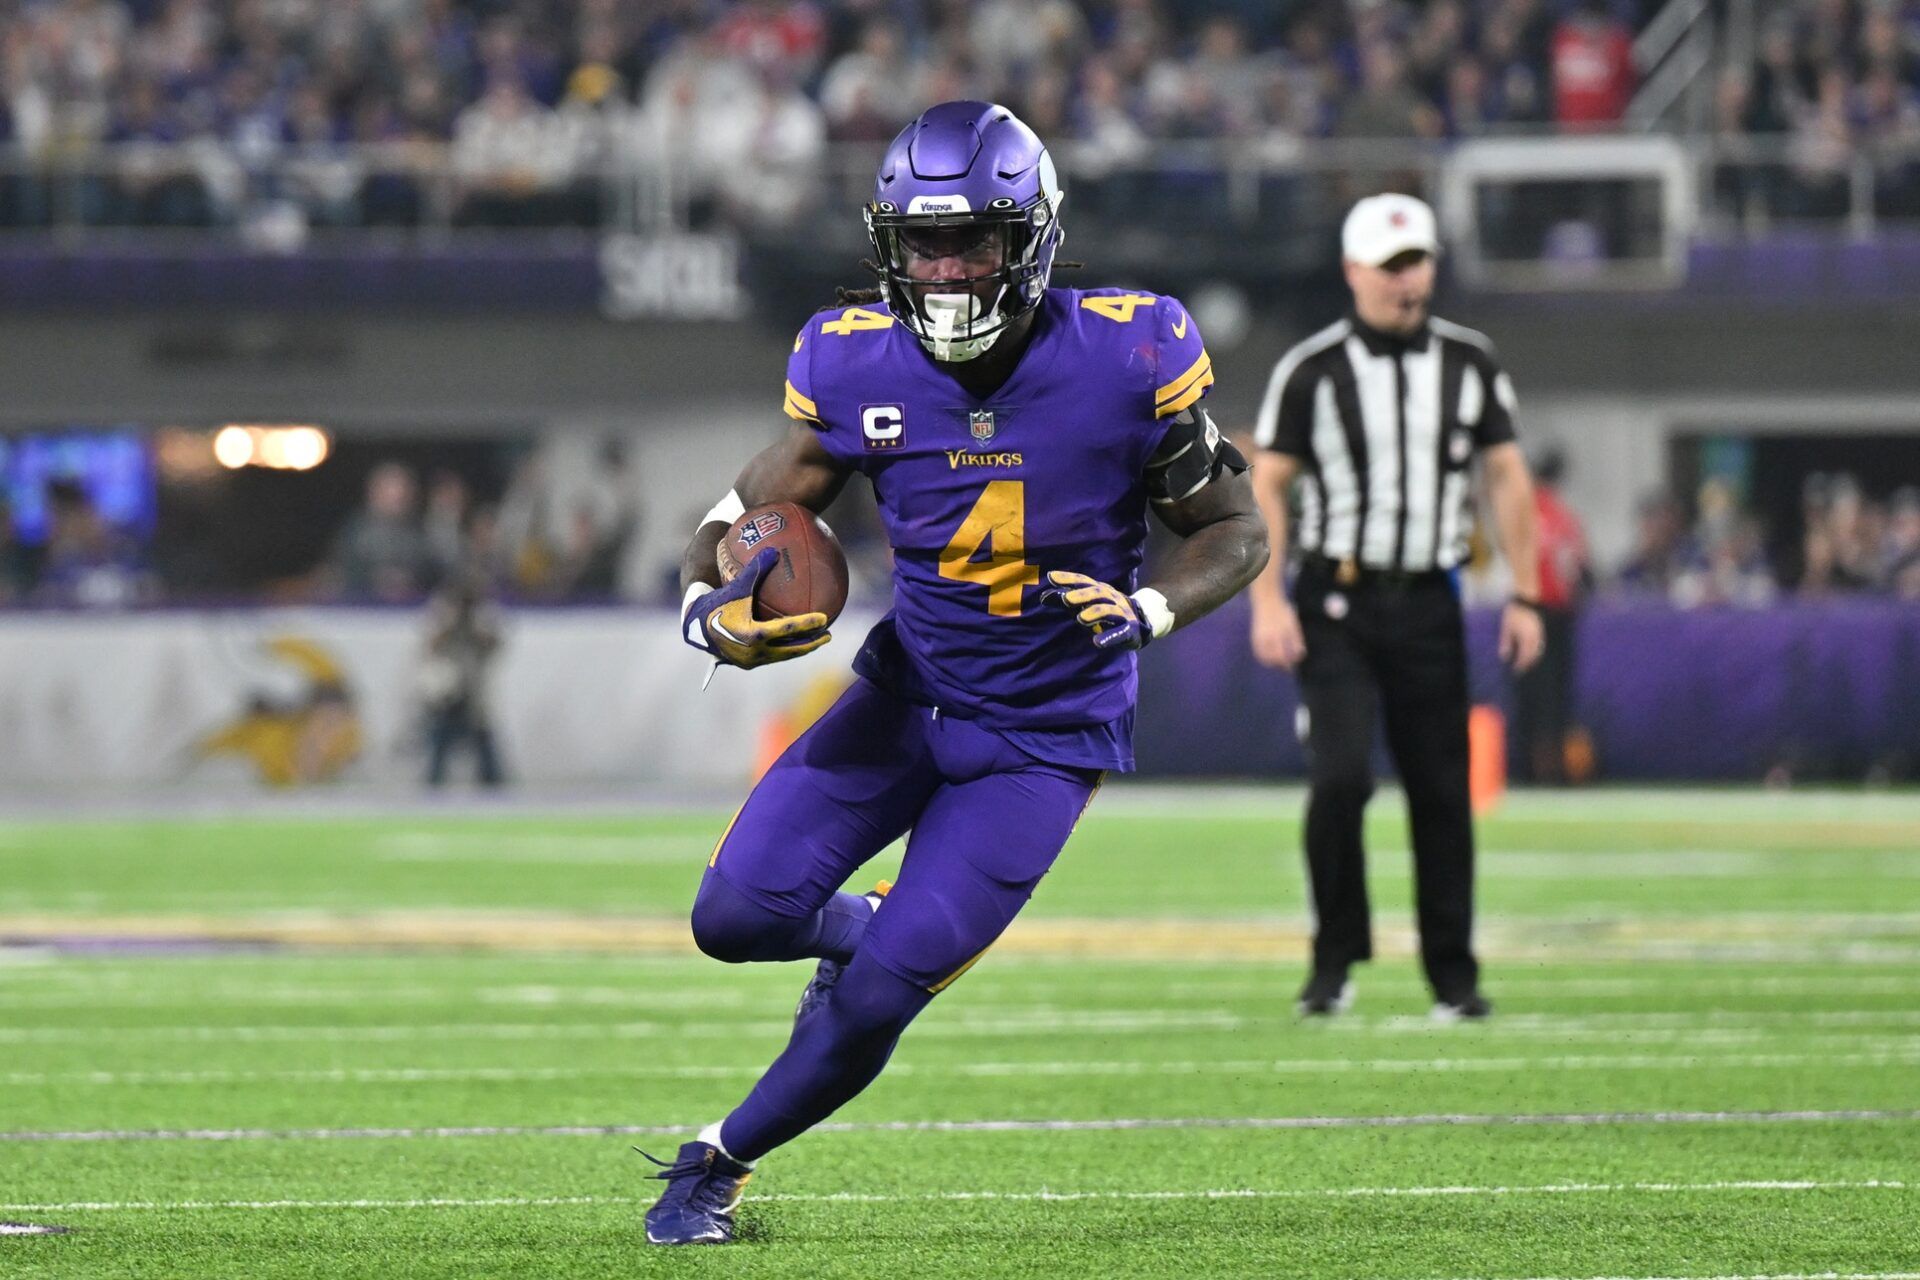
[0,608,870,791]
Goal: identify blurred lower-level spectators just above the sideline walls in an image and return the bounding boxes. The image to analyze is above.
[0,449,1920,608]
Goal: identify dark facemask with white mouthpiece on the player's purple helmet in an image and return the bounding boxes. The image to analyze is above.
[866,194,1066,363]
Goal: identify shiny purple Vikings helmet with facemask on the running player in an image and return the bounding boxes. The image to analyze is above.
[866,102,1066,361]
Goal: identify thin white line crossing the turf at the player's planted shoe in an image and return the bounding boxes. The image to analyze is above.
[0,1178,1916,1213]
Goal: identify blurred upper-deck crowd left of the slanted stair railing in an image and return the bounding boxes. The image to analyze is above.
[0,0,1657,225]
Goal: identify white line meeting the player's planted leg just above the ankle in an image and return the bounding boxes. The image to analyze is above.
[0,1109,1920,1142]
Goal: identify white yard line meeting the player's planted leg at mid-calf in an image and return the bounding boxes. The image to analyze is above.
[15,1036,1920,1086]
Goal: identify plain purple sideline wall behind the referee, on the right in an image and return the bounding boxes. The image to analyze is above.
[1137,597,1920,781]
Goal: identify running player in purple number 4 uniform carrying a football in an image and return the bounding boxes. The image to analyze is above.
[647,102,1267,1244]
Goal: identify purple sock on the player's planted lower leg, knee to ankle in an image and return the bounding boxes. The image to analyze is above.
[720,956,933,1163]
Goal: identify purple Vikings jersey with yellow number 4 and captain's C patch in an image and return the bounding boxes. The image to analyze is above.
[785,288,1213,770]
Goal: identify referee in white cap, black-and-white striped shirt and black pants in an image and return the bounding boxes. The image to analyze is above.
[1252,196,1542,1021]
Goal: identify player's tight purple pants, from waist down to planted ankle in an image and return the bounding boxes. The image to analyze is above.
[693,679,1100,1161]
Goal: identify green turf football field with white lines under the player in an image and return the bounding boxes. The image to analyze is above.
[0,787,1920,1280]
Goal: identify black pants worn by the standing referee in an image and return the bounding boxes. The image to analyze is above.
[1294,560,1478,1000]
